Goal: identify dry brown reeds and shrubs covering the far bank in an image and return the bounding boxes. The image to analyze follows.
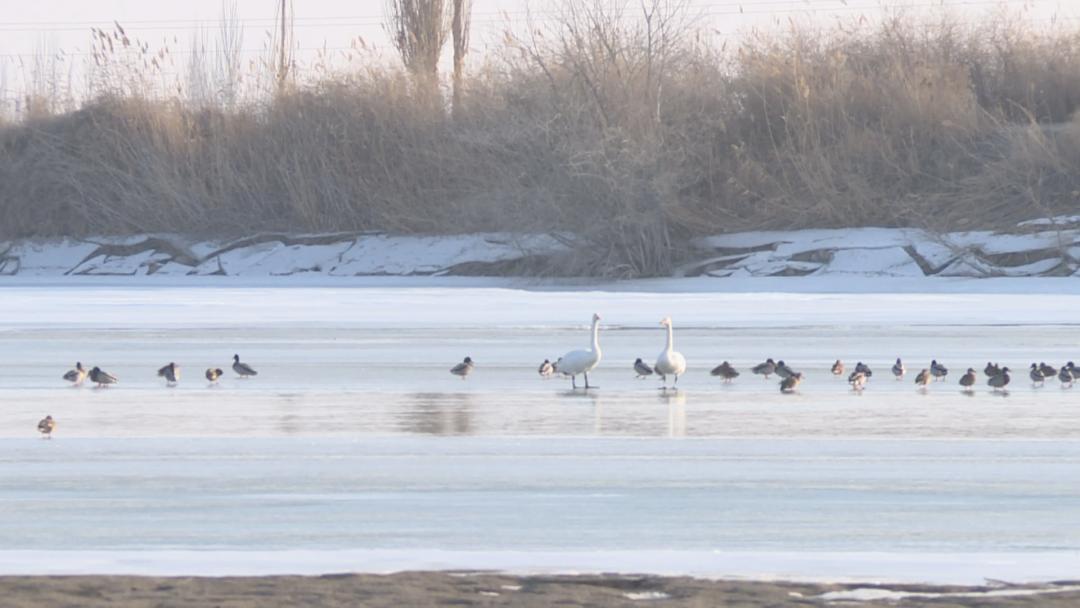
[0,0,1080,276]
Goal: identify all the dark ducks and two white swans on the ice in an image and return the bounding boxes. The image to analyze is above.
[31,314,1080,438]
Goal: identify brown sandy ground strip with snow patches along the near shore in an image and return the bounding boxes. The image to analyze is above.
[0,572,1080,608]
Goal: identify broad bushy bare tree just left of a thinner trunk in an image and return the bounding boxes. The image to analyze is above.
[387,0,448,103]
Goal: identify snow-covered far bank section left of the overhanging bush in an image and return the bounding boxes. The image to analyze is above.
[0,233,563,276]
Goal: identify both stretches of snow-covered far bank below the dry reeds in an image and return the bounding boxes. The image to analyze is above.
[6,223,1080,285]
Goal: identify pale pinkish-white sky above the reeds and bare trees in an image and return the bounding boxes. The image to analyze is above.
[0,0,1080,105]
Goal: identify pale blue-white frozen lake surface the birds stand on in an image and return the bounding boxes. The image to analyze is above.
[0,283,1080,582]
